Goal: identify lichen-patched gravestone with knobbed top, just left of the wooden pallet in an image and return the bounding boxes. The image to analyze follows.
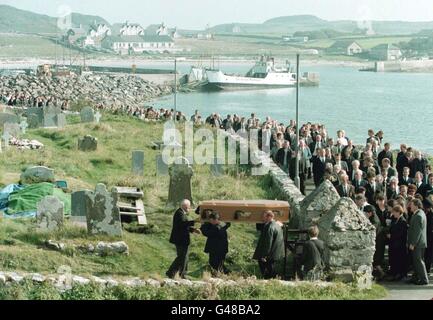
[85,184,122,236]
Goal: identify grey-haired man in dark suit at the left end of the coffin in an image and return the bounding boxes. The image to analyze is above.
[166,200,197,279]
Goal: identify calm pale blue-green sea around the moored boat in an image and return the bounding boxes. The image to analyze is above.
[152,64,433,154]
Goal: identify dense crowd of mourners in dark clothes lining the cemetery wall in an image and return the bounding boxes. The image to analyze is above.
[164,111,433,285]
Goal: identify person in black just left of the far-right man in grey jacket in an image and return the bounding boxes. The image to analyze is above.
[388,206,408,281]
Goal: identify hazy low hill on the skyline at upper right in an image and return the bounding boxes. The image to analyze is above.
[211,15,433,35]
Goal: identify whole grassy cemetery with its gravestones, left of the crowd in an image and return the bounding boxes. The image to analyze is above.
[0,109,384,299]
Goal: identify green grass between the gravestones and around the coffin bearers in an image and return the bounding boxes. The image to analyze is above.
[0,116,270,277]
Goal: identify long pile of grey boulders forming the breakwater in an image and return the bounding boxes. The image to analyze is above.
[0,74,172,109]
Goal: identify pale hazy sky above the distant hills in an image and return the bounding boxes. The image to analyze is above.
[0,0,433,29]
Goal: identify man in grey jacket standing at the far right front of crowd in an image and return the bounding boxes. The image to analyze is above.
[408,199,429,285]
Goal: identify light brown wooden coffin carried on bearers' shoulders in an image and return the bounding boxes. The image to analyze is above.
[198,200,290,223]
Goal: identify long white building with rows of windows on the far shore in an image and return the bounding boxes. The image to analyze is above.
[102,35,176,55]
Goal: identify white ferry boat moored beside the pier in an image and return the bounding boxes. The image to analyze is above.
[206,56,297,90]
